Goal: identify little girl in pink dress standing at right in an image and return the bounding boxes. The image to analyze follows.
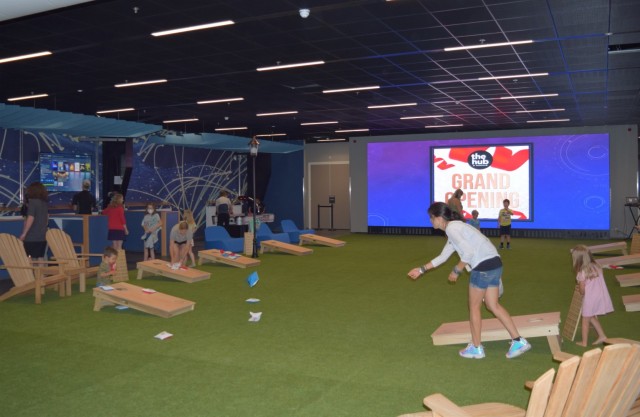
[571,245,613,346]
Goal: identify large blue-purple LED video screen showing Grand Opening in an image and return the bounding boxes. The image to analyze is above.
[367,134,610,230]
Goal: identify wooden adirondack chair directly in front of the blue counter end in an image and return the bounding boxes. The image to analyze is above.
[47,229,102,295]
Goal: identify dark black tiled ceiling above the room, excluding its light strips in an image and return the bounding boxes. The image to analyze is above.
[0,0,640,142]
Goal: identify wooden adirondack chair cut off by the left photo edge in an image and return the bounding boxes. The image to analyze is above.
[0,233,69,304]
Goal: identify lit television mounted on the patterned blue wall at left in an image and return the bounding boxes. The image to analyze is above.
[40,152,93,191]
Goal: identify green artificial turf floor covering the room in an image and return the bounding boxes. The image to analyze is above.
[0,234,640,417]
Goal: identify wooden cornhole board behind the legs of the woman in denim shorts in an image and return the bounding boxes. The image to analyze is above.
[431,311,562,354]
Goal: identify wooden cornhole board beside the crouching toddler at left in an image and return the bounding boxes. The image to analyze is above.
[93,282,196,318]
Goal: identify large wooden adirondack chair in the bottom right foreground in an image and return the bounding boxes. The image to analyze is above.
[402,344,640,417]
